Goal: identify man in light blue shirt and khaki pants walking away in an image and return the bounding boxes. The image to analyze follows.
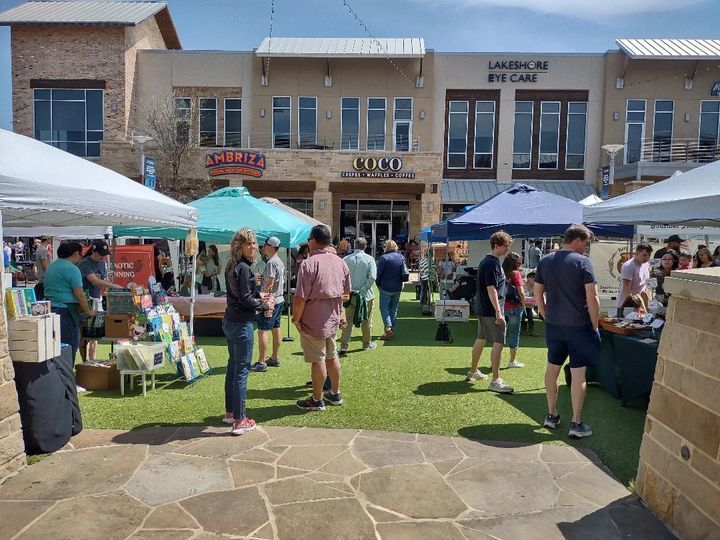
[340,238,377,354]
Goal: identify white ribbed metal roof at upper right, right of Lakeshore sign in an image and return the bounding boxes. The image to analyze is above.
[615,39,720,60]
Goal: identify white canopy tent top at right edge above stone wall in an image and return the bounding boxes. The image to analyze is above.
[583,161,720,226]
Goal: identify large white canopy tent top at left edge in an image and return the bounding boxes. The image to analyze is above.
[0,129,198,228]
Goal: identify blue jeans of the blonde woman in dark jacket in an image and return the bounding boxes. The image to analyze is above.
[223,319,254,420]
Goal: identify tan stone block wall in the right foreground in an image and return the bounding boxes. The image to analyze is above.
[637,268,720,539]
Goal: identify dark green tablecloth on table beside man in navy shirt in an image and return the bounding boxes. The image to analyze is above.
[587,330,660,405]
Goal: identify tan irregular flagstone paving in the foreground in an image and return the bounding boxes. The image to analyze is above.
[0,426,674,540]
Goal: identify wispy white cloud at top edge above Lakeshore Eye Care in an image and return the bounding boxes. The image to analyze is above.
[414,0,708,19]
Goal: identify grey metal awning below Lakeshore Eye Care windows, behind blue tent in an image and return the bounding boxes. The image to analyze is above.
[440,180,595,204]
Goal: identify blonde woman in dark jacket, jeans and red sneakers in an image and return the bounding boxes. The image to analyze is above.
[222,228,275,435]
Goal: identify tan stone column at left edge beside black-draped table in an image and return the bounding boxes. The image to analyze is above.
[0,288,26,480]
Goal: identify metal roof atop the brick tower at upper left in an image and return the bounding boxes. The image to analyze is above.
[0,2,167,26]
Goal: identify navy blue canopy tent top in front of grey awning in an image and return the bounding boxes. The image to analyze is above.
[430,184,634,242]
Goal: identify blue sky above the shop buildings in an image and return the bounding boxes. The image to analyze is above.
[0,0,720,129]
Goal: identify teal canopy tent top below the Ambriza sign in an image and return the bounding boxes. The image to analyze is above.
[113,187,312,247]
